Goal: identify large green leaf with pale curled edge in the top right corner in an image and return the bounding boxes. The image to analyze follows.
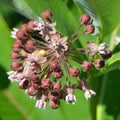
[74,0,120,38]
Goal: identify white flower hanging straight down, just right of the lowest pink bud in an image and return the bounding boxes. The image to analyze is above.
[65,88,76,105]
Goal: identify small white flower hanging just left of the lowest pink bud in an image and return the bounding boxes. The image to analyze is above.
[35,95,47,110]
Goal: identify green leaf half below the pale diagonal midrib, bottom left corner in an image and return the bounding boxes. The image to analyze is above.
[0,90,30,120]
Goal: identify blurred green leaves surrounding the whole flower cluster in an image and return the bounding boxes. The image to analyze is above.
[0,0,120,120]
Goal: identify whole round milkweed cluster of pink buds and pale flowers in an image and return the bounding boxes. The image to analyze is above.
[7,10,111,109]
